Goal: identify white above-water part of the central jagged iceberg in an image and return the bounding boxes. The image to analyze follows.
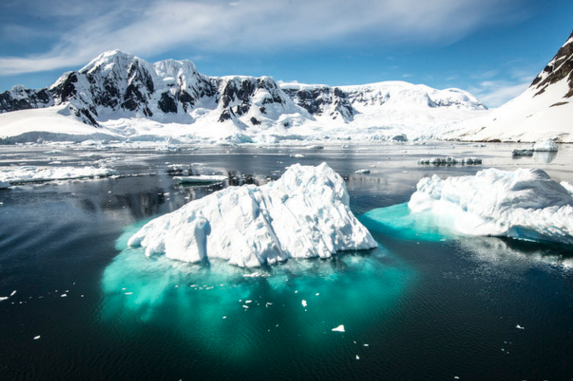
[128,163,377,267]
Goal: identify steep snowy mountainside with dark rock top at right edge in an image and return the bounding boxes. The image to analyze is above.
[452,28,573,142]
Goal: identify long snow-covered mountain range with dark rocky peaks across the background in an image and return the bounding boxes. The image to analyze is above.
[0,50,486,141]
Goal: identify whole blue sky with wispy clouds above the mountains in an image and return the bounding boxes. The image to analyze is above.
[0,0,573,108]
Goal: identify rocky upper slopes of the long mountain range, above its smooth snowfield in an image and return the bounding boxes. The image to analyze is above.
[0,50,484,129]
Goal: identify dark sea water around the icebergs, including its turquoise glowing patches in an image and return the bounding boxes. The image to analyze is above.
[0,144,573,380]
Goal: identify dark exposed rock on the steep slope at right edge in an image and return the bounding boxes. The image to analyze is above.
[530,32,573,98]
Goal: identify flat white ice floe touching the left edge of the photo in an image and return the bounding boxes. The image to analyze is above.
[0,166,117,188]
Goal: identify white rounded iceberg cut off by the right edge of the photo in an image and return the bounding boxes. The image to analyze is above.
[408,168,573,244]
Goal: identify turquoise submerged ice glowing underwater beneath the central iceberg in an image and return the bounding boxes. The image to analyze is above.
[101,211,416,359]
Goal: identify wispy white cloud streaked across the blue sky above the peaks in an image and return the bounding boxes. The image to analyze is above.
[0,0,525,75]
